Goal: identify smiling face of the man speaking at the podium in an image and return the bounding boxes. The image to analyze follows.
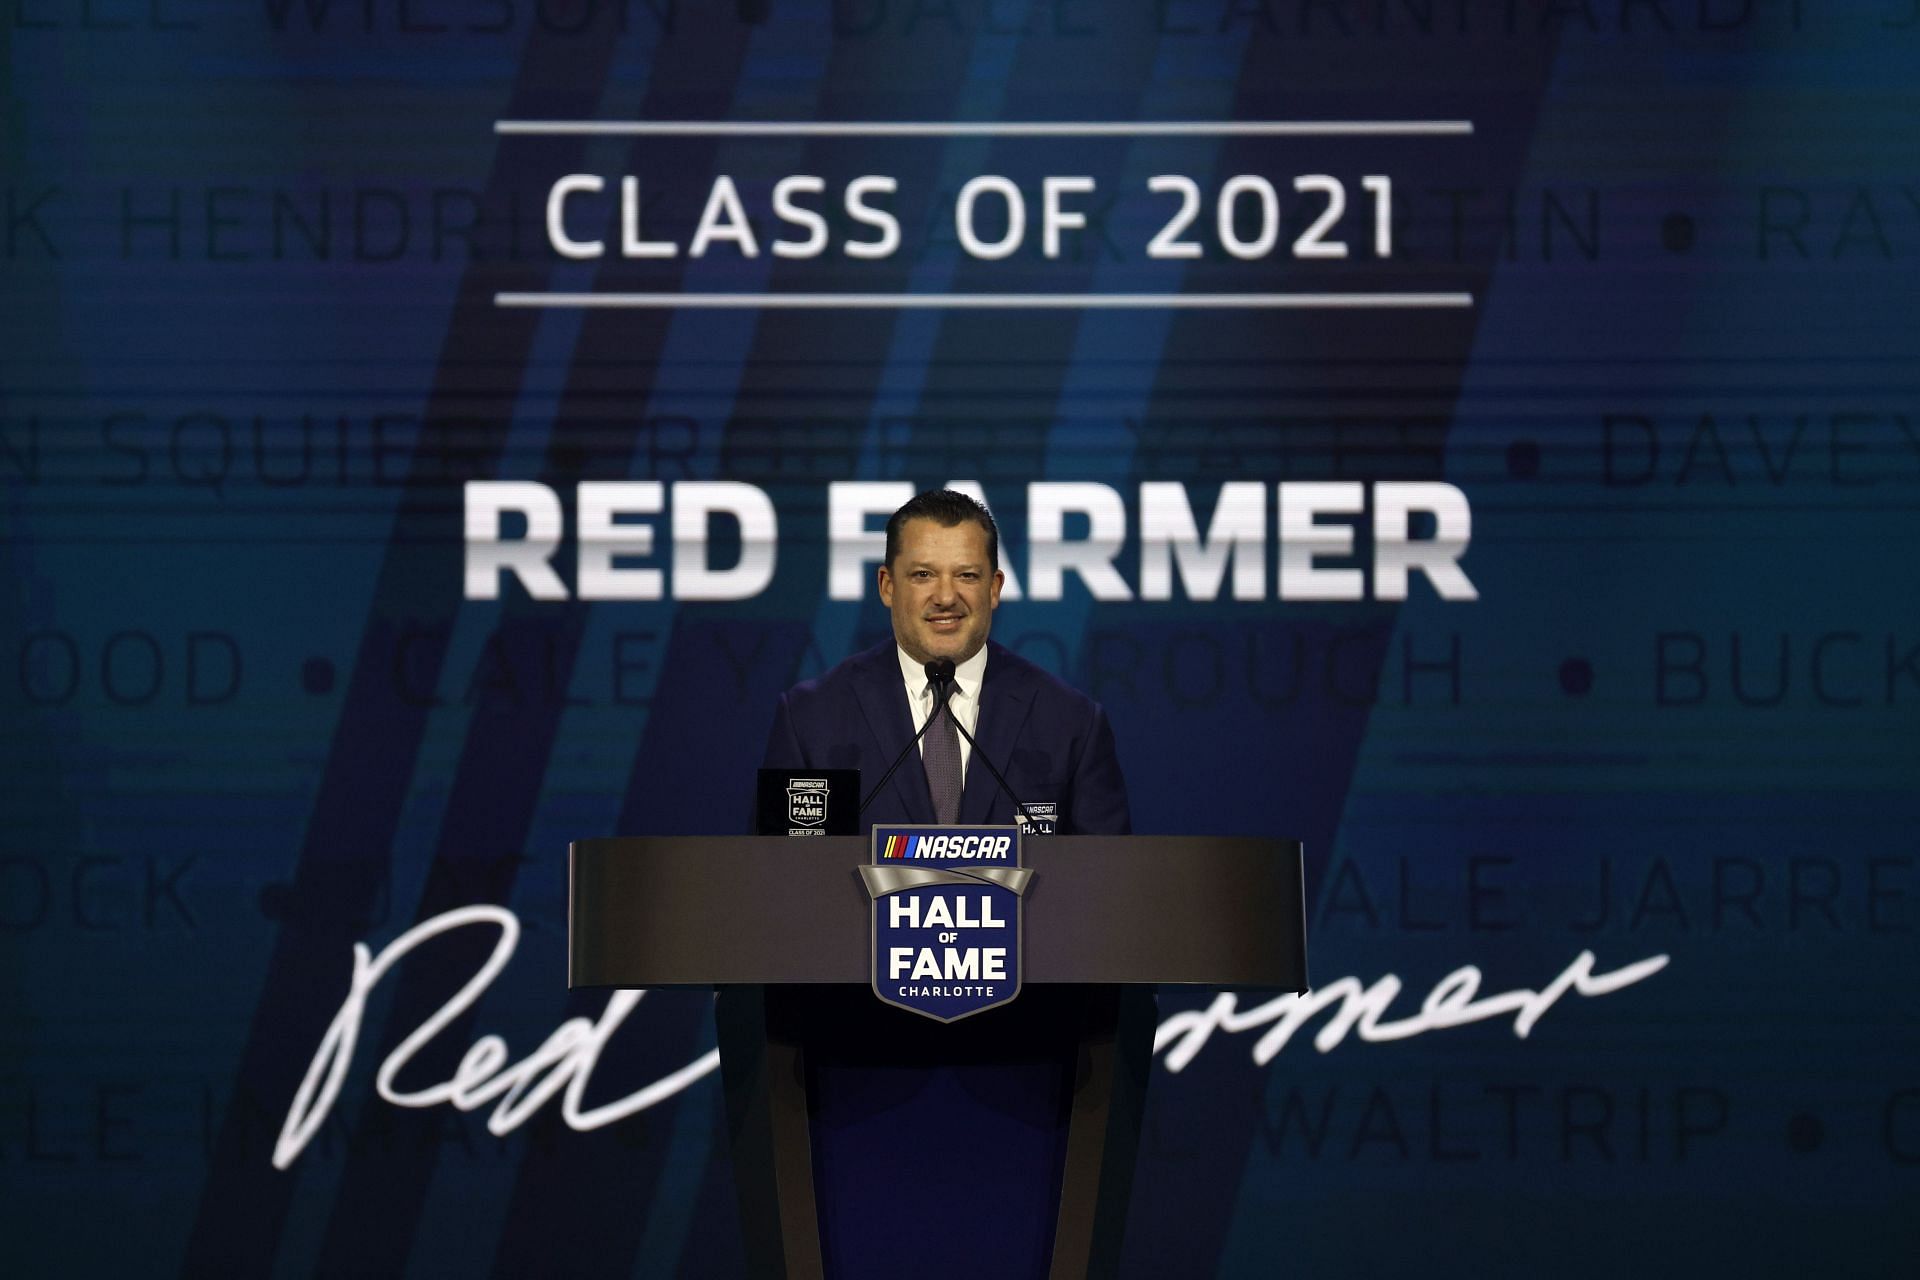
[879,520,1006,662]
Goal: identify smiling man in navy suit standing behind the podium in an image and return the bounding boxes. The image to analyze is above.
[766,489,1131,835]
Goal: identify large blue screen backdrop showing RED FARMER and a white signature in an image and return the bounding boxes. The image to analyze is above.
[0,0,1920,1276]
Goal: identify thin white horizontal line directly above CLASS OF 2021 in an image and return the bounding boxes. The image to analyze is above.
[493,121,1473,138]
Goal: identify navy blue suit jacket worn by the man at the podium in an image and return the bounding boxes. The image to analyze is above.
[766,639,1133,835]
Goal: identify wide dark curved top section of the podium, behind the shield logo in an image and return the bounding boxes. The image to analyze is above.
[566,835,1308,990]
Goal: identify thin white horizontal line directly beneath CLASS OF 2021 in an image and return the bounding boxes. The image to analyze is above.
[493,294,1473,311]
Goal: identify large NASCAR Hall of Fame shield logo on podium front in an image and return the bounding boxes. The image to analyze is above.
[860,827,1033,1023]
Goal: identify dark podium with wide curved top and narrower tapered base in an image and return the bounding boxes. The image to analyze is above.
[566,835,1308,1280]
